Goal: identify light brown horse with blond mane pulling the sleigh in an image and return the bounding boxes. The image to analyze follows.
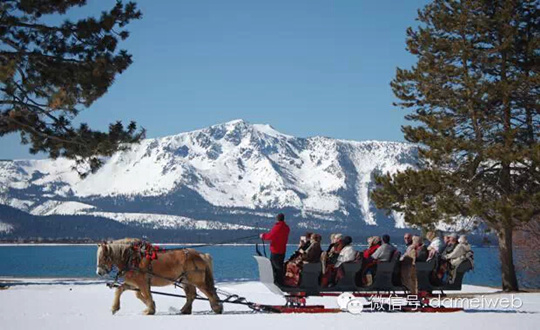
[96,239,223,315]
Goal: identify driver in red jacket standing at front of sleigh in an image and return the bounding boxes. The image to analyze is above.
[261,213,291,284]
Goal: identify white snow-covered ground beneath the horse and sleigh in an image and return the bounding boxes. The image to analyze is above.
[0,279,540,330]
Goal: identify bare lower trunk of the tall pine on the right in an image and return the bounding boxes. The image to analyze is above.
[498,226,519,292]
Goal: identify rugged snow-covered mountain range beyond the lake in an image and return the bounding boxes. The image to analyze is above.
[0,120,417,233]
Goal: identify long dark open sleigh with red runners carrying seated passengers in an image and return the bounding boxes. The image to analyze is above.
[254,252,472,313]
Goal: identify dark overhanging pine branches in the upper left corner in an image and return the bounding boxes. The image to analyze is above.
[0,0,144,176]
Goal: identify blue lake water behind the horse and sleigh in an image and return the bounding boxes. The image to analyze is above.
[0,245,532,286]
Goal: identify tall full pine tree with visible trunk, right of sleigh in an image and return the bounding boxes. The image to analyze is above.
[372,0,540,291]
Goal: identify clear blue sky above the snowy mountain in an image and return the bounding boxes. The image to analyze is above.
[0,0,427,159]
